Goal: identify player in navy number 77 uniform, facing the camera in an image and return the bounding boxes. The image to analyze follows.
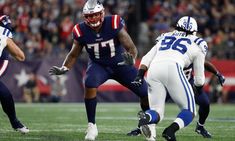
[49,0,149,140]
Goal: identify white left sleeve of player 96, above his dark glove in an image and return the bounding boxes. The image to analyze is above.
[140,45,157,68]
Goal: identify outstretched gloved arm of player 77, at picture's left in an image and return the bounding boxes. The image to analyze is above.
[49,40,83,75]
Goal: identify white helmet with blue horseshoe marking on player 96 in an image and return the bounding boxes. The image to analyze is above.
[176,16,198,32]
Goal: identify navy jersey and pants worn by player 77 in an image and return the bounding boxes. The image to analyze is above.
[73,15,147,97]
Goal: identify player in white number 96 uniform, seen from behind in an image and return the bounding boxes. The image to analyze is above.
[133,16,208,141]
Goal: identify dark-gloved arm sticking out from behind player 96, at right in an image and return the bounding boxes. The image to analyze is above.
[204,61,225,86]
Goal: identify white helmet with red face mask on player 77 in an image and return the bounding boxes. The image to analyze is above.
[83,0,104,29]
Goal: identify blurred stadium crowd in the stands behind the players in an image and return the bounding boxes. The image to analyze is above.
[0,0,235,60]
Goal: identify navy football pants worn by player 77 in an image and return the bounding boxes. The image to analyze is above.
[85,62,148,98]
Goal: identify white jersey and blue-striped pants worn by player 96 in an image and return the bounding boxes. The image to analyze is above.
[141,30,208,120]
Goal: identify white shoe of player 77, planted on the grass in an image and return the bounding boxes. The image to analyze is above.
[85,122,98,141]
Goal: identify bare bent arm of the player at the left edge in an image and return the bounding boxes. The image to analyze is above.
[6,38,25,61]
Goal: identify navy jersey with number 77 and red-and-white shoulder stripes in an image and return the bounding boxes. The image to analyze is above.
[73,15,125,66]
